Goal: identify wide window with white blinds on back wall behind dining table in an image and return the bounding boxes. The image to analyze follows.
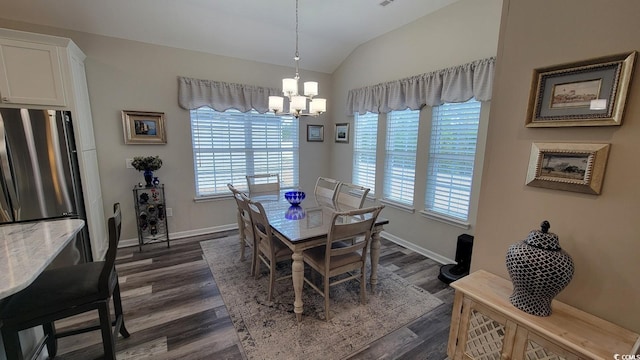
[191,107,298,197]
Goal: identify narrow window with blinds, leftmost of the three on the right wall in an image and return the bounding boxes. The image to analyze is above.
[351,112,378,195]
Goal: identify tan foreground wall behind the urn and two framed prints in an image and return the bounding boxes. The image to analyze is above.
[472,0,640,332]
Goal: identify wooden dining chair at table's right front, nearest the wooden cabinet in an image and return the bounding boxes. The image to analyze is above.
[303,205,384,321]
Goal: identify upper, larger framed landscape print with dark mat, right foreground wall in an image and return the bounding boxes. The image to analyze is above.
[526,51,636,127]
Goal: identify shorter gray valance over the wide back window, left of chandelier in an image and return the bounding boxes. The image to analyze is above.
[178,77,282,114]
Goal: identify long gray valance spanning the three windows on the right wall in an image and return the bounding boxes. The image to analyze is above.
[347,57,495,115]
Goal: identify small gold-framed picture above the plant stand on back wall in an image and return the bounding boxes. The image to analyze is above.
[122,110,167,145]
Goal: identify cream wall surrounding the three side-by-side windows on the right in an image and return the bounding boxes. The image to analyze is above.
[331,0,502,259]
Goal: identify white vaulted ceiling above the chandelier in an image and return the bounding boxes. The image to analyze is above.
[0,0,458,73]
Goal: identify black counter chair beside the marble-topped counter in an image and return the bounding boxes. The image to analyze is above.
[0,203,129,360]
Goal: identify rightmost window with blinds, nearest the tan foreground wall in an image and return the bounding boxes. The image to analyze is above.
[425,99,480,221]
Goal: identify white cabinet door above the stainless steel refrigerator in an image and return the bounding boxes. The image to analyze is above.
[0,38,67,106]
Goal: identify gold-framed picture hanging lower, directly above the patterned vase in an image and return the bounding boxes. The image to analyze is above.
[527,143,610,195]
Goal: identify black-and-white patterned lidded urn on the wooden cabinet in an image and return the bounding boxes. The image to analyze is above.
[507,221,574,316]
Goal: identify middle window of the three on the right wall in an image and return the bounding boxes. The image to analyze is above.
[383,109,420,206]
